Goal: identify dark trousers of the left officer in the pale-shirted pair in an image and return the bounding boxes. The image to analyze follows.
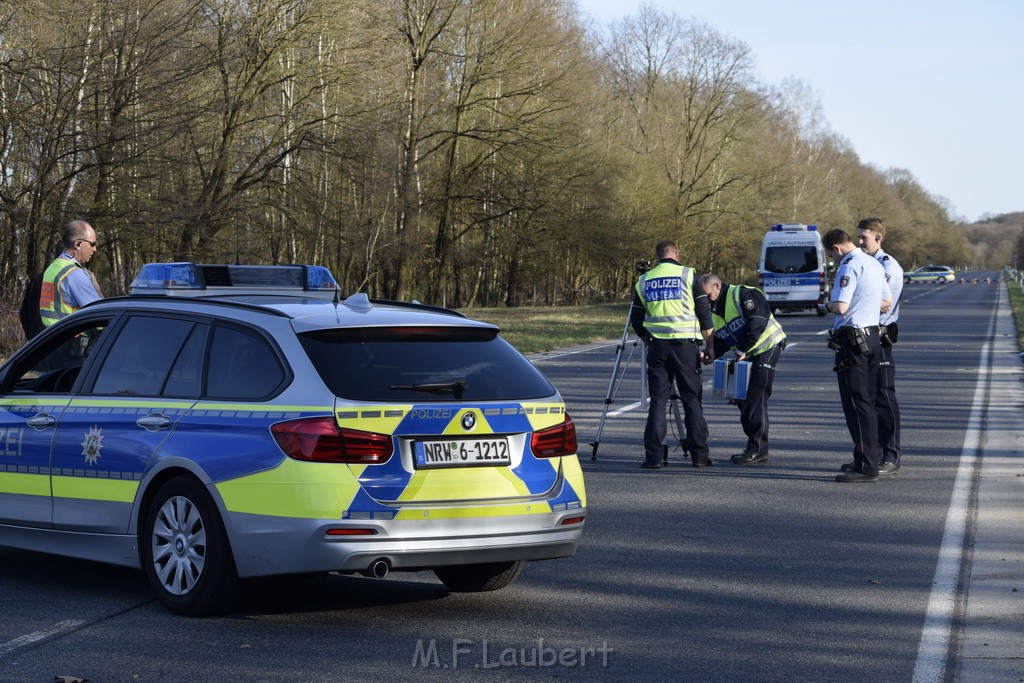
[835,328,882,476]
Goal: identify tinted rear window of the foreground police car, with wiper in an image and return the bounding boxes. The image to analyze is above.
[299,327,555,402]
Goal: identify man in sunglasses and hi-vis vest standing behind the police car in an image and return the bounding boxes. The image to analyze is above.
[39,220,103,327]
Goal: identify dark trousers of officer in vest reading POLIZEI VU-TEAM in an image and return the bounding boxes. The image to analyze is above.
[643,337,708,465]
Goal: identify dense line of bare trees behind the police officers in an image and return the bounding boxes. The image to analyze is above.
[0,0,972,306]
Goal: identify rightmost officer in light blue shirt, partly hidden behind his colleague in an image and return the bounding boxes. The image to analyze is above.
[843,218,903,475]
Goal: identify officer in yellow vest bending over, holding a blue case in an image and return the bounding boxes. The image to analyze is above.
[700,273,785,465]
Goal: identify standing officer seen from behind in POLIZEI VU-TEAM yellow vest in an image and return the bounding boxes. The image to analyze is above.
[630,241,714,469]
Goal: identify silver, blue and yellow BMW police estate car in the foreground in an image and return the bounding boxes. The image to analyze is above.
[0,263,587,615]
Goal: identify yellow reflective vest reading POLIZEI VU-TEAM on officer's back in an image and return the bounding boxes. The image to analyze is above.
[637,262,700,339]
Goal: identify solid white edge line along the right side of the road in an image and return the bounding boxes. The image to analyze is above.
[911,339,998,683]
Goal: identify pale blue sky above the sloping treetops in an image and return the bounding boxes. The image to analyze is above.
[577,0,1024,221]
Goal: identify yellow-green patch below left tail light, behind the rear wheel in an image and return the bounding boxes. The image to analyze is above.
[215,458,359,519]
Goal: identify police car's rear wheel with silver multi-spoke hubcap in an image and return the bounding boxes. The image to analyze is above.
[139,476,239,616]
